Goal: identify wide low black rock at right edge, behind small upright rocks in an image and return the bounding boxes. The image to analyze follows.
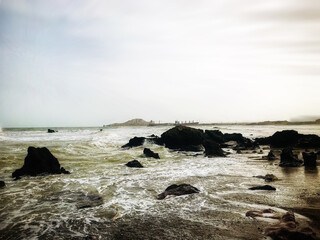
[255,130,320,148]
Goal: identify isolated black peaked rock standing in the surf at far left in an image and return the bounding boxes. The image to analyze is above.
[12,147,69,178]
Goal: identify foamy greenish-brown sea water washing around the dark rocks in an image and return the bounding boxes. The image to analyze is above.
[0,125,320,239]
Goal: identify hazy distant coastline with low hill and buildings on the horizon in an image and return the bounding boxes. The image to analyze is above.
[103,118,320,127]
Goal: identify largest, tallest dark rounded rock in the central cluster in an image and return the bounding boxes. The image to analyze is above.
[161,126,204,151]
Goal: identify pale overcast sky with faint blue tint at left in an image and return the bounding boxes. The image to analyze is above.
[0,0,320,127]
